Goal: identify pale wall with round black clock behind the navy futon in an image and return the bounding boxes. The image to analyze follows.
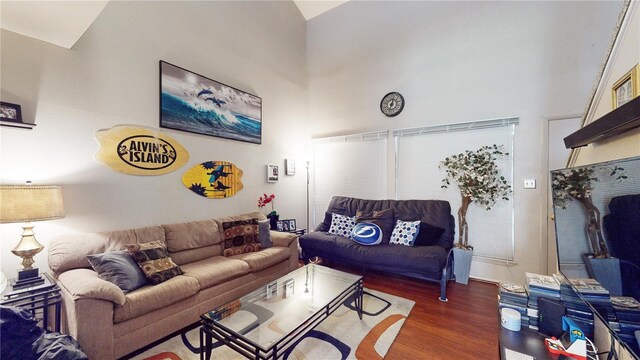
[307,1,622,282]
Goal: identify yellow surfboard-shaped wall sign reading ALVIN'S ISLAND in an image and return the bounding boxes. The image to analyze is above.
[96,125,189,175]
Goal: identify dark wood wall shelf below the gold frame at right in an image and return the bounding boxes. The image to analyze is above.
[564,97,640,149]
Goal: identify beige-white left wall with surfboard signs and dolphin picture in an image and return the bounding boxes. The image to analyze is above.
[0,1,308,278]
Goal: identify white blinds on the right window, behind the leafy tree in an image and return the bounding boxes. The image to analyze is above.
[393,118,518,261]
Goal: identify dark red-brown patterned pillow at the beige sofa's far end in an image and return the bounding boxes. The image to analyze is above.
[222,219,262,257]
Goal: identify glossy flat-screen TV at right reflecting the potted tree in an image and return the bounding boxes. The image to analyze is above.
[551,157,640,357]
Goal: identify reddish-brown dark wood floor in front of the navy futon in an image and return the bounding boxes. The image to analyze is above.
[332,266,500,360]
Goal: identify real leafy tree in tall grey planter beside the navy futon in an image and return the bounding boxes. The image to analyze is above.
[439,144,511,284]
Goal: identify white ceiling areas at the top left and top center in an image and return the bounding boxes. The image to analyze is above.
[0,0,346,49]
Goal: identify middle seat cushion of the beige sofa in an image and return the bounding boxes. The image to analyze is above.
[180,256,250,289]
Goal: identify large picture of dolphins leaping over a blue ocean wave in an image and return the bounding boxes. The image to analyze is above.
[160,60,262,144]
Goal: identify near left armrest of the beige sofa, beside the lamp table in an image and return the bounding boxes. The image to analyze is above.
[57,269,125,305]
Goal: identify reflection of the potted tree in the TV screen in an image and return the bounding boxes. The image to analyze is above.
[551,166,627,295]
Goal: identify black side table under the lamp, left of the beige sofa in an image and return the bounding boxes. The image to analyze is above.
[0,273,62,332]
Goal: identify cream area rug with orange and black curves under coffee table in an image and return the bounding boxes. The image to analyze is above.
[133,288,415,360]
